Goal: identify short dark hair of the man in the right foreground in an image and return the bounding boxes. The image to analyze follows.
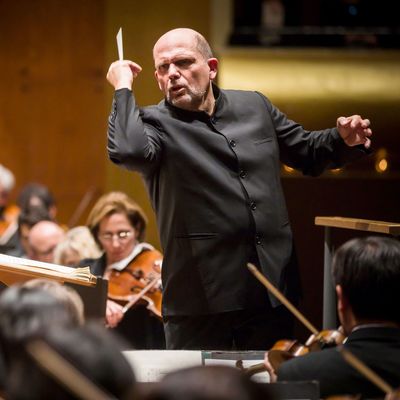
[332,236,400,323]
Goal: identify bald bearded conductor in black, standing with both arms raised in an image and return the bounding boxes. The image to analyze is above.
[107,28,372,350]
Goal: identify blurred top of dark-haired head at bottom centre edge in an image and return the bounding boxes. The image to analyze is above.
[145,366,269,400]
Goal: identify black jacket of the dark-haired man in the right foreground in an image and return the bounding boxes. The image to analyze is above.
[277,326,400,398]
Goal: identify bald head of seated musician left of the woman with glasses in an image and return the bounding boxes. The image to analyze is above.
[28,221,65,263]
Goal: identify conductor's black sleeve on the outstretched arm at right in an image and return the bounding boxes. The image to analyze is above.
[261,95,368,176]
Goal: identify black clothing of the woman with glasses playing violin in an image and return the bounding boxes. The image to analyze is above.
[79,243,165,350]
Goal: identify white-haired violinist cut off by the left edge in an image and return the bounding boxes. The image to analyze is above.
[0,164,19,254]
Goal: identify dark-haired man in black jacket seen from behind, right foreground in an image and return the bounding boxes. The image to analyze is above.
[266,237,400,398]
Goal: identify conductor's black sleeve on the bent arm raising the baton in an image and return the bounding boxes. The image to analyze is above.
[107,89,162,174]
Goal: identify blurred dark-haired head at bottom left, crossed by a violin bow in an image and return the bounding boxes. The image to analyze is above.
[7,323,135,400]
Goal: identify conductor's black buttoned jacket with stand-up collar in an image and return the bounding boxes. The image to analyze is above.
[108,86,364,348]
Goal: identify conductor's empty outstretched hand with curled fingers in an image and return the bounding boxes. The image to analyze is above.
[336,115,372,149]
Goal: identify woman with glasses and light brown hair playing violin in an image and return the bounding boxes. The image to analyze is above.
[81,192,165,349]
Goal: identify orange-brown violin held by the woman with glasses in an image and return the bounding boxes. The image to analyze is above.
[108,250,163,319]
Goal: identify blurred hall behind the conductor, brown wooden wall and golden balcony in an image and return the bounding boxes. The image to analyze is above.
[0,0,400,337]
